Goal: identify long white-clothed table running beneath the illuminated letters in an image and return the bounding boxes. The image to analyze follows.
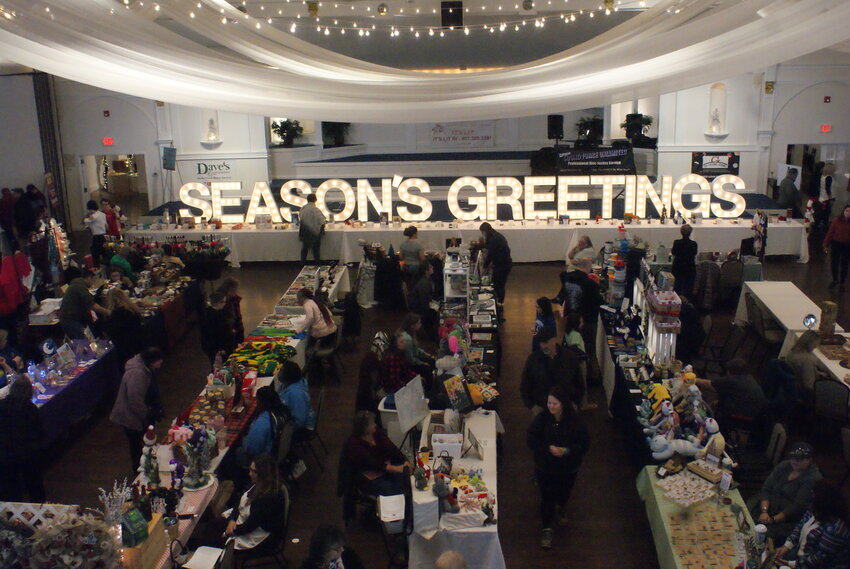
[126,219,809,266]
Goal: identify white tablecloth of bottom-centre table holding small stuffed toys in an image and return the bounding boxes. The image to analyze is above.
[407,409,505,569]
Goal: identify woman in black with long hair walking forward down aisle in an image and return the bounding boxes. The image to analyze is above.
[528,386,590,549]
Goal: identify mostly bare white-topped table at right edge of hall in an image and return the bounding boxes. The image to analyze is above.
[735,281,844,354]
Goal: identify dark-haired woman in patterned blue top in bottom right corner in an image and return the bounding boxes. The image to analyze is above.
[776,480,850,569]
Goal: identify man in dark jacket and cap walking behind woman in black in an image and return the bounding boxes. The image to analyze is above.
[520,326,584,415]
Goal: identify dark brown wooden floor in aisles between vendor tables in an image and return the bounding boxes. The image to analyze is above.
[46,237,850,569]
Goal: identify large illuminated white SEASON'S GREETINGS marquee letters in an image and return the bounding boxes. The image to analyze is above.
[180,174,746,223]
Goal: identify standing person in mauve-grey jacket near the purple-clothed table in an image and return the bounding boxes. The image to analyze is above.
[109,347,165,472]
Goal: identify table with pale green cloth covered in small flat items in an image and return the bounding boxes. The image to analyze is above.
[637,466,753,569]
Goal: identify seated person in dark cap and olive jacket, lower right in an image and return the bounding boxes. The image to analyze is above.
[747,443,822,543]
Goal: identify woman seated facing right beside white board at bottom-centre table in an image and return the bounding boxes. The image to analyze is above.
[347,411,410,496]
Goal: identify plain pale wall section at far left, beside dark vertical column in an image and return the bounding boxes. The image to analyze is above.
[0,75,44,188]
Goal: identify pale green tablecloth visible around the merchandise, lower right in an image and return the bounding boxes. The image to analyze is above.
[637,466,753,569]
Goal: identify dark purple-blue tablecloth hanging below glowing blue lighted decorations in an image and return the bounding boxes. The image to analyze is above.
[35,340,121,441]
